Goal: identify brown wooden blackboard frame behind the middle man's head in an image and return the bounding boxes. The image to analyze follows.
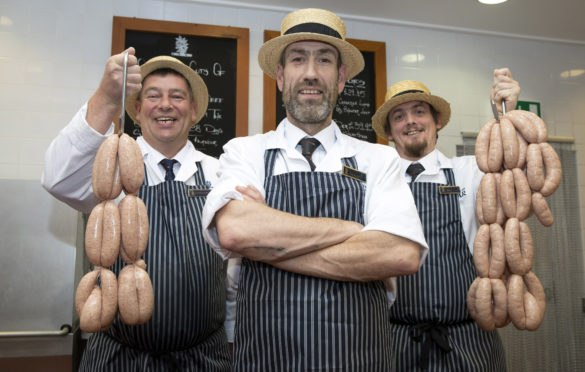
[262,30,388,144]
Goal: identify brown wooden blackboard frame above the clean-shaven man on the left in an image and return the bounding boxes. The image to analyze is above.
[112,16,250,156]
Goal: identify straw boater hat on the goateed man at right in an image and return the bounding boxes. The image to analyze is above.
[372,80,451,140]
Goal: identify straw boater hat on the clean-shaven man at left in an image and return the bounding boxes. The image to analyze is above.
[126,56,209,125]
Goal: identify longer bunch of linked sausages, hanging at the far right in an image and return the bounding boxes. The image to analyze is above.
[467,110,562,331]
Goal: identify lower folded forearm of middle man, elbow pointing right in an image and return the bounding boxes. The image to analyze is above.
[271,231,423,281]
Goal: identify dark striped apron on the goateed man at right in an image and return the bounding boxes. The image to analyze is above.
[390,169,506,372]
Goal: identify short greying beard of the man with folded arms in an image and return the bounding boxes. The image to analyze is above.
[282,79,338,124]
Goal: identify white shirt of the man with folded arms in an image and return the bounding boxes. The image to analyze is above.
[202,119,428,308]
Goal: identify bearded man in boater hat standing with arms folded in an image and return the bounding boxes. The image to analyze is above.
[203,9,427,371]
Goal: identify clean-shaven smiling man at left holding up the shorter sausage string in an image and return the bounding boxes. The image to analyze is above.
[42,48,230,371]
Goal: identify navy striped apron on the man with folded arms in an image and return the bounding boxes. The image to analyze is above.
[234,150,390,372]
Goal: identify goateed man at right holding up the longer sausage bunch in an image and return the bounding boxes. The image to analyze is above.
[372,69,520,371]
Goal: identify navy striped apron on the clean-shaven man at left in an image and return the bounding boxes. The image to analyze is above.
[80,163,230,372]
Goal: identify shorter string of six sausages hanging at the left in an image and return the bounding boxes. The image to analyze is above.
[75,134,154,333]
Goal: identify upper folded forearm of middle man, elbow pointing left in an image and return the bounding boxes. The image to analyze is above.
[215,200,362,262]
